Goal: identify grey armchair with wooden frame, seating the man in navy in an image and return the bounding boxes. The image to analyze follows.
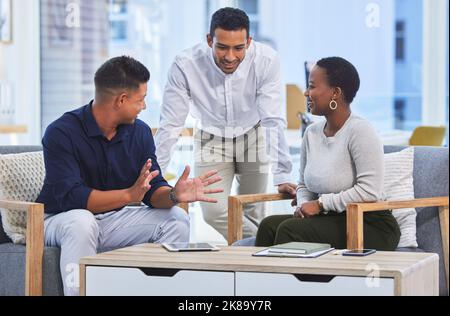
[0,146,188,296]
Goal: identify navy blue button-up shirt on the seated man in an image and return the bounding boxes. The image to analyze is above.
[36,102,169,213]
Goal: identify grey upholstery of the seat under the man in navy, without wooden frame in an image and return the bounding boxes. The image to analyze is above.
[0,146,63,296]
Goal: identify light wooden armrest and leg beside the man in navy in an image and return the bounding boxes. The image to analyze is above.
[0,200,44,296]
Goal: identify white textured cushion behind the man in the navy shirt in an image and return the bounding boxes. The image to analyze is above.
[0,152,45,244]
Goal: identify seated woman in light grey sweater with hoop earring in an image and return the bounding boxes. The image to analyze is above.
[256,57,400,251]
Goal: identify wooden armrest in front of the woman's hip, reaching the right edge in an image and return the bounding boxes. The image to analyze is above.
[347,196,449,289]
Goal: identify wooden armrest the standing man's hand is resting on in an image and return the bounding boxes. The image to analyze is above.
[228,193,292,245]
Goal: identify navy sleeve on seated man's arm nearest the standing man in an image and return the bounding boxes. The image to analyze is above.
[142,124,171,208]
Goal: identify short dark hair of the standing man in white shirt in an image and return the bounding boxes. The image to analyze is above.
[209,8,250,38]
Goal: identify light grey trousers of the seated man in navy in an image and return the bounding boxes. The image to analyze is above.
[44,206,189,296]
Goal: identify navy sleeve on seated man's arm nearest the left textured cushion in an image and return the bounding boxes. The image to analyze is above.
[42,127,93,213]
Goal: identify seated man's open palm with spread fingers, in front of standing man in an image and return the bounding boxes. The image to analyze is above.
[174,166,223,203]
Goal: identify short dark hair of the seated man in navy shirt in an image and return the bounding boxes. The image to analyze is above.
[94,56,150,93]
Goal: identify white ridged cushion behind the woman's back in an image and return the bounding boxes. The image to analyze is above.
[384,147,418,248]
